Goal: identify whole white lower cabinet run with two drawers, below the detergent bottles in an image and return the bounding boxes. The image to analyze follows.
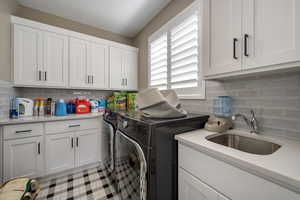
[0,118,102,180]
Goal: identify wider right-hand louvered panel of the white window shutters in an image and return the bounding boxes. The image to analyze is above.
[170,12,199,89]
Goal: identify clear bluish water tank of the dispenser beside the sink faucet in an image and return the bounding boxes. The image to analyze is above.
[213,96,232,118]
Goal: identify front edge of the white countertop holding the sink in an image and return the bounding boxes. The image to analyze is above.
[175,135,300,194]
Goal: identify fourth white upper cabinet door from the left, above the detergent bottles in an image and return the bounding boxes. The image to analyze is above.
[88,43,109,89]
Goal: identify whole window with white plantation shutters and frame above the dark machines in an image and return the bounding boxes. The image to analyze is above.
[149,2,205,99]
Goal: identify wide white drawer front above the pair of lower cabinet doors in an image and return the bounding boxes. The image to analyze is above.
[45,119,100,134]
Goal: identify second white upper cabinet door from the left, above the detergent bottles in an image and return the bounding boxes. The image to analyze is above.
[43,32,69,87]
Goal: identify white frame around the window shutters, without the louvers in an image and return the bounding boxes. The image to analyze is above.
[147,0,206,99]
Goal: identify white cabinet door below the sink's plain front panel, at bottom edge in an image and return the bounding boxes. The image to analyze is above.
[179,168,221,200]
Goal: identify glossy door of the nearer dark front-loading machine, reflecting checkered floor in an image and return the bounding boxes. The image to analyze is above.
[115,131,147,200]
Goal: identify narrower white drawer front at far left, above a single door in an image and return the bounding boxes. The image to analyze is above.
[3,123,44,140]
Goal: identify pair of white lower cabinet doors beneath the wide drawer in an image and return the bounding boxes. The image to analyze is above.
[46,129,100,174]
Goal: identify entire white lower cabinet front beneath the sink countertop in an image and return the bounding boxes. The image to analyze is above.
[178,144,300,200]
